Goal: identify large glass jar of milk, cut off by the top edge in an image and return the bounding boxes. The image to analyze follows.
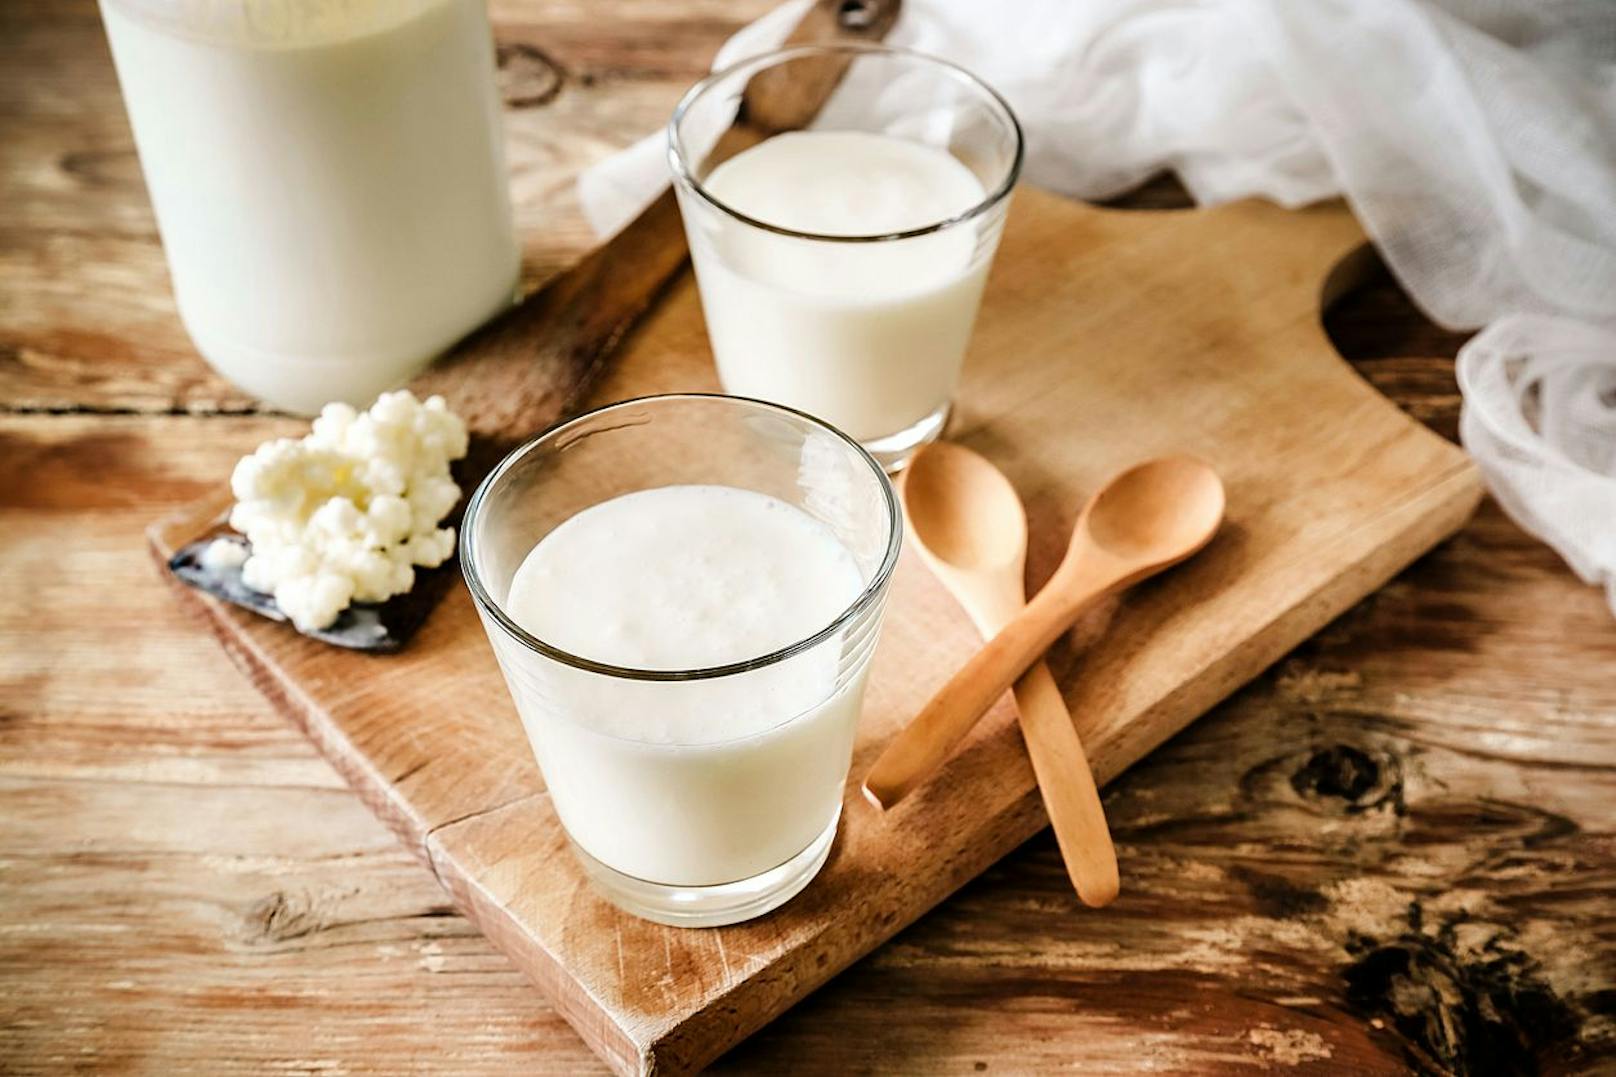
[100,0,519,412]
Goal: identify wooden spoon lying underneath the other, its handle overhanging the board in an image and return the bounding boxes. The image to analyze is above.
[902,441,1118,907]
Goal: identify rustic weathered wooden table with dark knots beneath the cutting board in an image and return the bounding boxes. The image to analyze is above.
[0,0,1616,1074]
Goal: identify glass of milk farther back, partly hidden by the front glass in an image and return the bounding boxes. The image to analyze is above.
[669,45,1021,469]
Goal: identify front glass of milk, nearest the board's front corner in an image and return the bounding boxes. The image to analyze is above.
[461,395,902,927]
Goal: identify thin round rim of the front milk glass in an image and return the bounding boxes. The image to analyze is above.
[457,393,903,682]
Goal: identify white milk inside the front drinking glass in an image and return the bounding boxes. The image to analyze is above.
[504,485,868,886]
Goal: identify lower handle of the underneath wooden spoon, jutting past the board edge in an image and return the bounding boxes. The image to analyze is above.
[1015,661,1122,909]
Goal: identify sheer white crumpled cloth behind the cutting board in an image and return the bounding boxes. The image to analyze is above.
[579,0,1616,608]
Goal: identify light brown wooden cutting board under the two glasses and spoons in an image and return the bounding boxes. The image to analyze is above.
[152,189,1480,1074]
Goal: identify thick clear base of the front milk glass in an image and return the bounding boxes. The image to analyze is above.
[572,805,842,927]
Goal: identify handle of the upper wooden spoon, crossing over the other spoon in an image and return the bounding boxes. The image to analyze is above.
[865,574,1118,809]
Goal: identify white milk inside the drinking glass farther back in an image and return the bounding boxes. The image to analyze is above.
[685,131,992,441]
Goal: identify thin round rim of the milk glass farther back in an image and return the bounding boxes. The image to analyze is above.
[667,42,1026,243]
